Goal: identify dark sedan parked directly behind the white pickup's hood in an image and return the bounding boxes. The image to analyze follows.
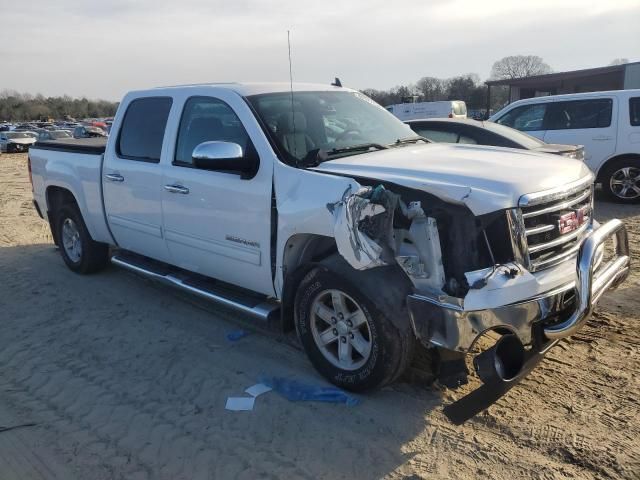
[405,118,584,160]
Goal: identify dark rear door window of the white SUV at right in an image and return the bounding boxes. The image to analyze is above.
[545,98,613,130]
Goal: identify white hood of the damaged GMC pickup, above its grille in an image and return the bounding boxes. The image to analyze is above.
[314,143,593,215]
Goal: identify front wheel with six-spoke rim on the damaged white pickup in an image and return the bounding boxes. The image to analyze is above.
[294,259,415,392]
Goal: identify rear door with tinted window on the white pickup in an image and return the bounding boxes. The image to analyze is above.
[102,97,172,261]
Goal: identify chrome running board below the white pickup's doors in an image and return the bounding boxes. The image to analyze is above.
[111,251,280,322]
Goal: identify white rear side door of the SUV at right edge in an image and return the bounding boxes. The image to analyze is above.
[544,97,617,172]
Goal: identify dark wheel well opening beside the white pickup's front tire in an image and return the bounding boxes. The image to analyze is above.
[281,233,338,332]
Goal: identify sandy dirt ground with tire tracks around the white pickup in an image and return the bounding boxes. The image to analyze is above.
[0,154,640,480]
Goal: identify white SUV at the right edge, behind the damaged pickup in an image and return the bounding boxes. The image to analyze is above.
[489,90,640,203]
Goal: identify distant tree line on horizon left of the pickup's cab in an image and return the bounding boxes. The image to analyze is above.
[0,90,118,122]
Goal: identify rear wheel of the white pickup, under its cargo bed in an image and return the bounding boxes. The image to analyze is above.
[56,205,109,274]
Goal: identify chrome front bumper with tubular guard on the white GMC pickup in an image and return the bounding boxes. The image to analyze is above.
[407,220,629,352]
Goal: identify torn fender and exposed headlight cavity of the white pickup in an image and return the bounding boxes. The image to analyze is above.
[327,183,513,298]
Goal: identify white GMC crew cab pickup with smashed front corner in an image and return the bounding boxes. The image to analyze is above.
[29,84,629,420]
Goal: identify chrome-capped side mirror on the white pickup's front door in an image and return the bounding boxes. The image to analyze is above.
[191,141,258,178]
